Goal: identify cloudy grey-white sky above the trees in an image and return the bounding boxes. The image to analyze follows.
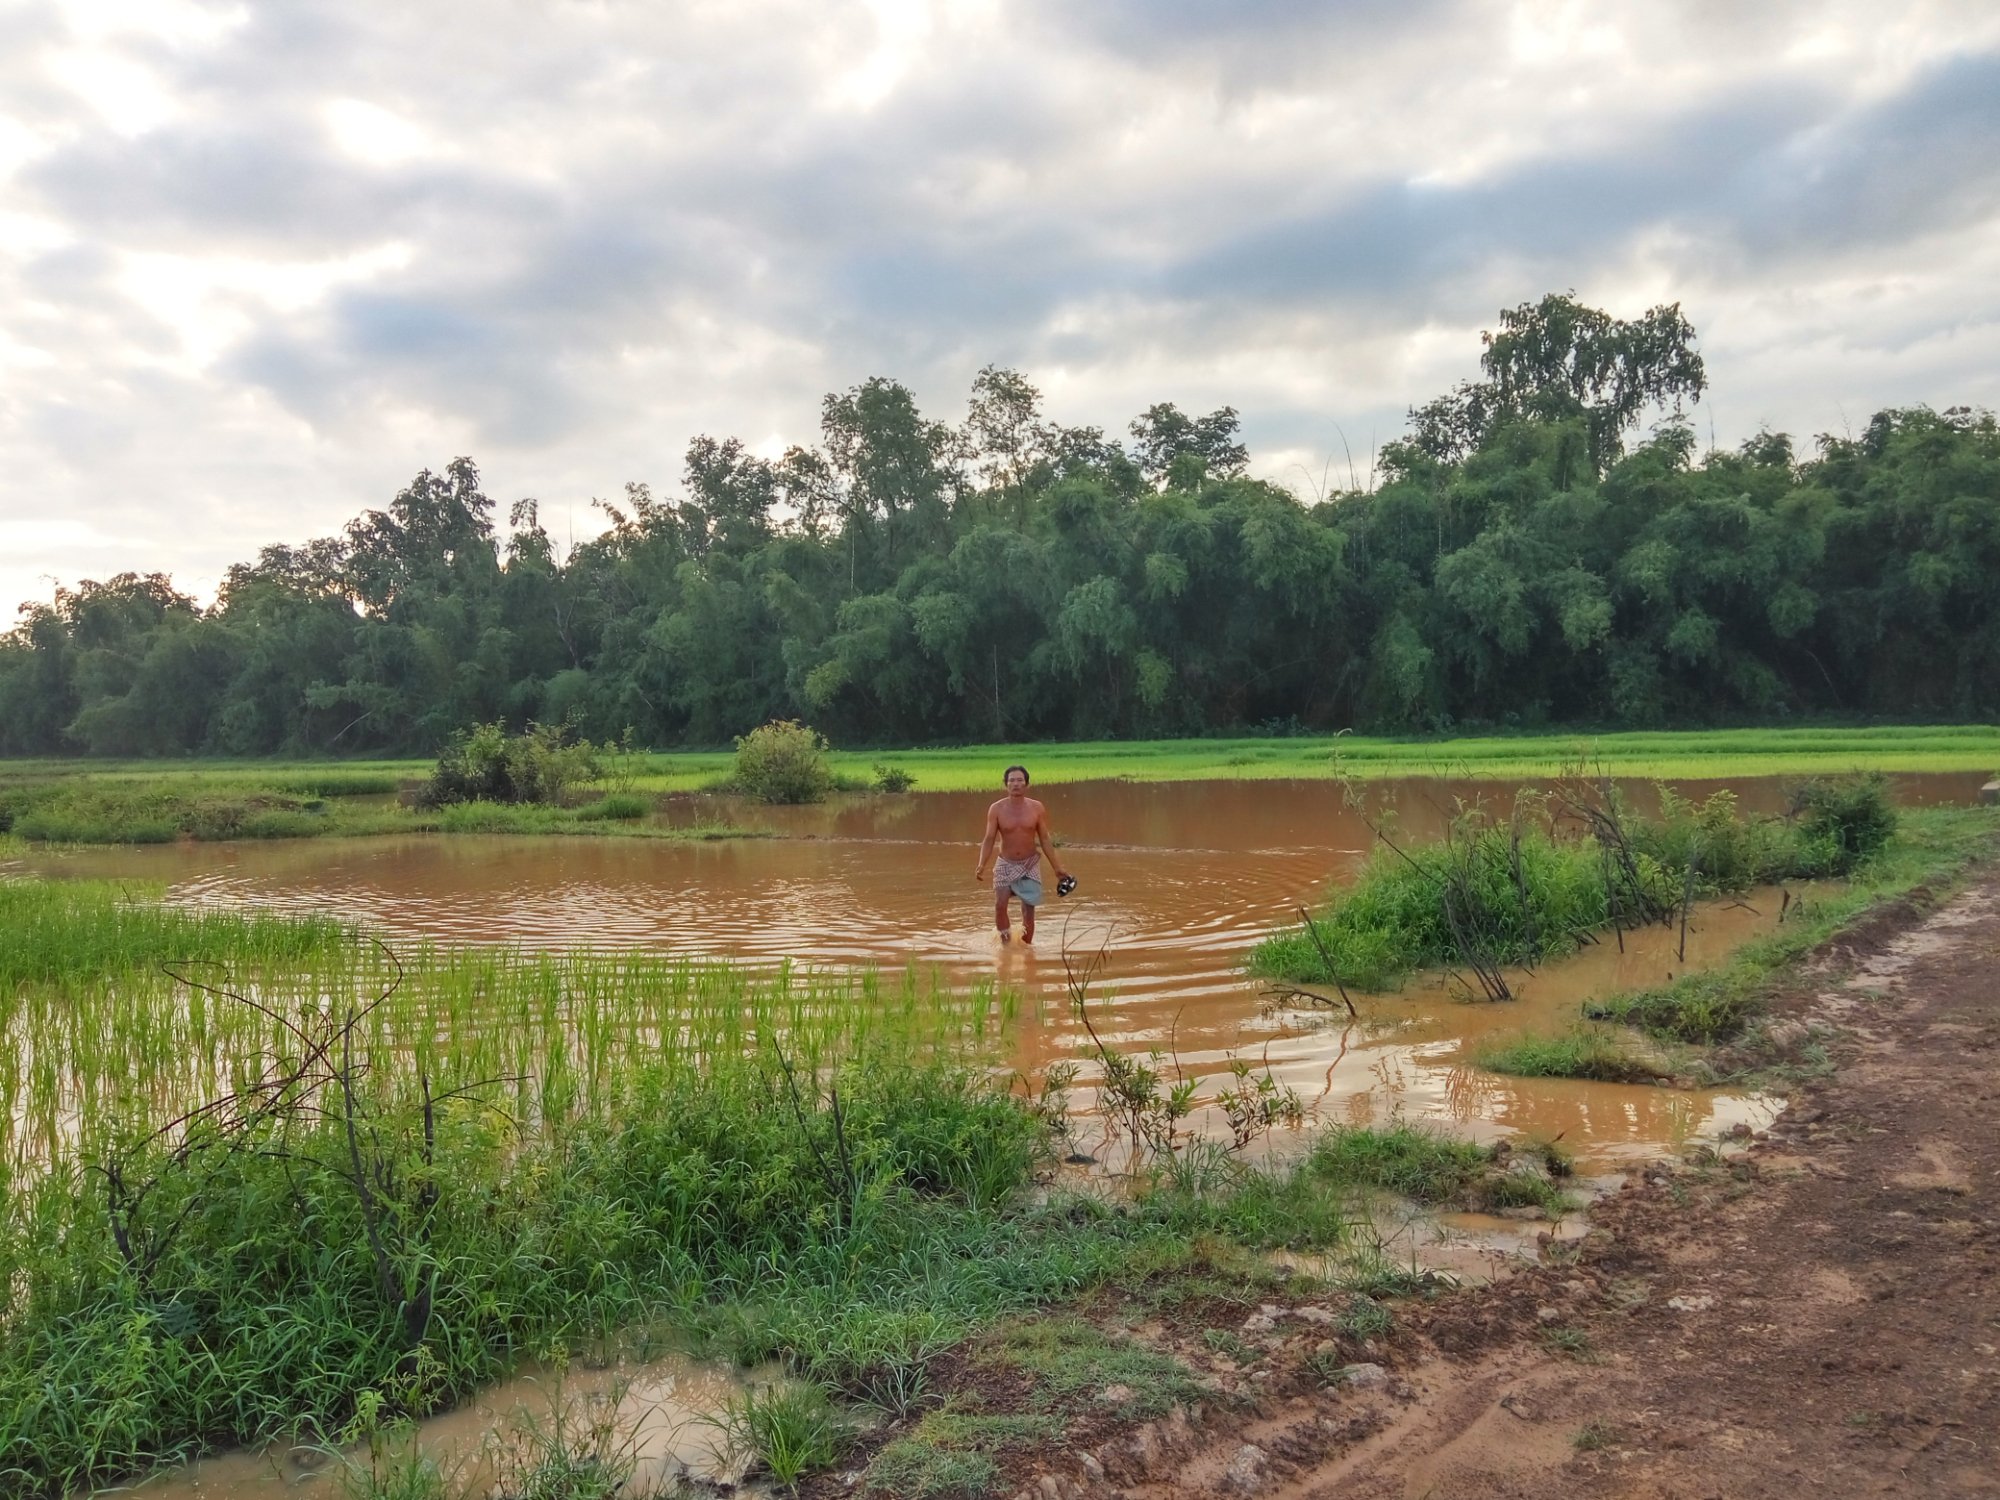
[0,0,2000,620]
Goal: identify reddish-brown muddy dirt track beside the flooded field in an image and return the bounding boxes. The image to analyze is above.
[916,870,2000,1500]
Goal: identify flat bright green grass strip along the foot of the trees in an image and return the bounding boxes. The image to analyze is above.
[0,726,2000,842]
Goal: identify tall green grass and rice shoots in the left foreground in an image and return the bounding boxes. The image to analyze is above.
[0,882,1550,1496]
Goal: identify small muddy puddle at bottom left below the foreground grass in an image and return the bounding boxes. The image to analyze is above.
[109,1360,750,1500]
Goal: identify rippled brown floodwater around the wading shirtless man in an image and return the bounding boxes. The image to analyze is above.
[22,776,1980,1170]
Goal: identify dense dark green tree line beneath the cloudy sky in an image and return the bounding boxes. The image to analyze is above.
[0,294,2000,756]
